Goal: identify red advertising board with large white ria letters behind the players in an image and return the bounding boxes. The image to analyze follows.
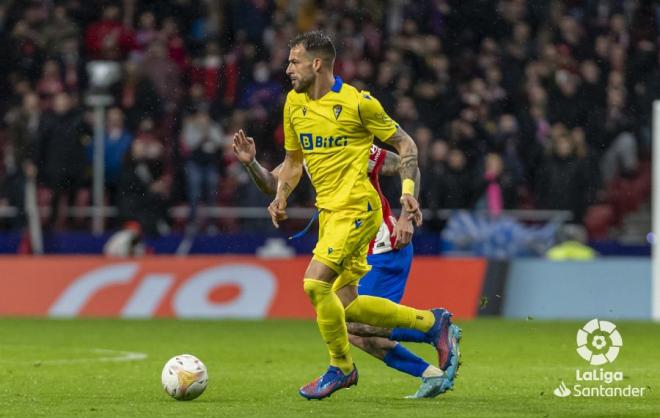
[0,256,487,318]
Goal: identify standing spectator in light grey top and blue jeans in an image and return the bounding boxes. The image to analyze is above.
[181,108,224,224]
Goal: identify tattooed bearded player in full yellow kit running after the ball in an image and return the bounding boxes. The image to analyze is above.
[268,31,448,399]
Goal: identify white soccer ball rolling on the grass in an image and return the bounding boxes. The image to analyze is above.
[161,354,209,401]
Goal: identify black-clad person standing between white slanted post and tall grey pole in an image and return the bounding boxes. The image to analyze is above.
[36,92,91,227]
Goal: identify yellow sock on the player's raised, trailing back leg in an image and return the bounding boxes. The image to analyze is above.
[346,296,435,332]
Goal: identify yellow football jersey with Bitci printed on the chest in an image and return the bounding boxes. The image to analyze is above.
[284,77,397,211]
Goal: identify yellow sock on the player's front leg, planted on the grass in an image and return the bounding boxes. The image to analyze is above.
[303,279,353,374]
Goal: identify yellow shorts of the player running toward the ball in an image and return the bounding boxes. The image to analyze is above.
[313,208,383,290]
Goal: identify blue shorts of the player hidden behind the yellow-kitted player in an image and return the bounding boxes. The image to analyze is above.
[358,244,413,303]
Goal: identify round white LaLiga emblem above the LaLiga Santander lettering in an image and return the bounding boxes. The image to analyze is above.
[577,319,623,366]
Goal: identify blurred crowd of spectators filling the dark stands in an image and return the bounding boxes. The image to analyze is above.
[0,0,660,234]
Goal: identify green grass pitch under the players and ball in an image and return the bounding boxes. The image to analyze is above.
[0,319,660,418]
